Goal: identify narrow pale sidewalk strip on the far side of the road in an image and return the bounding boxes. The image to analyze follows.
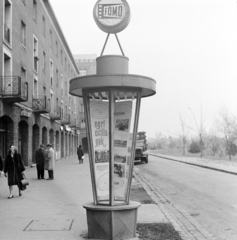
[149,152,237,175]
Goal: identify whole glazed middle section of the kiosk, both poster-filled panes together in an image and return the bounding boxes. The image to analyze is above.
[83,88,140,205]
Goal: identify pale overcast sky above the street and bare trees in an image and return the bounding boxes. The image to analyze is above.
[50,0,237,138]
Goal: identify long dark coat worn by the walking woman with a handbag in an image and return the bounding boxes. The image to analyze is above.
[4,151,25,190]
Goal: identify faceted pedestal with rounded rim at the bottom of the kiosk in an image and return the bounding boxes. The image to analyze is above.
[83,201,141,240]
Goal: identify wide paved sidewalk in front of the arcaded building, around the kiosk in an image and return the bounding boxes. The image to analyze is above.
[0,156,167,240]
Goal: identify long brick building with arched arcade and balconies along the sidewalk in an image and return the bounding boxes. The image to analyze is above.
[0,0,80,166]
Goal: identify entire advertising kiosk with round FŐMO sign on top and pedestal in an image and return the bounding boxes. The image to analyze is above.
[70,0,156,239]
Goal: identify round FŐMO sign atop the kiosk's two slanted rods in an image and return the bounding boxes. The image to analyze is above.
[93,0,131,33]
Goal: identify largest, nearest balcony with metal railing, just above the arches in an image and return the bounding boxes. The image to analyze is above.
[0,76,28,103]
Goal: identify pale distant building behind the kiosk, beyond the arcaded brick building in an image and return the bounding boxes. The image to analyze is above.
[74,54,97,152]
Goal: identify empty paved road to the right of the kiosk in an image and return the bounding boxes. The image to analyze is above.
[135,156,237,240]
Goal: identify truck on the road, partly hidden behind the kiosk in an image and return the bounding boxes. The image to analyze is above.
[134,132,148,163]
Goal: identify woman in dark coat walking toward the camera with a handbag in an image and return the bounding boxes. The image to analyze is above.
[4,145,25,199]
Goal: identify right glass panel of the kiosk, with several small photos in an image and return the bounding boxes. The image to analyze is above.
[113,92,139,204]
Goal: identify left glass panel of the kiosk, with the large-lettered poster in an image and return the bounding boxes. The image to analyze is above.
[89,92,110,204]
